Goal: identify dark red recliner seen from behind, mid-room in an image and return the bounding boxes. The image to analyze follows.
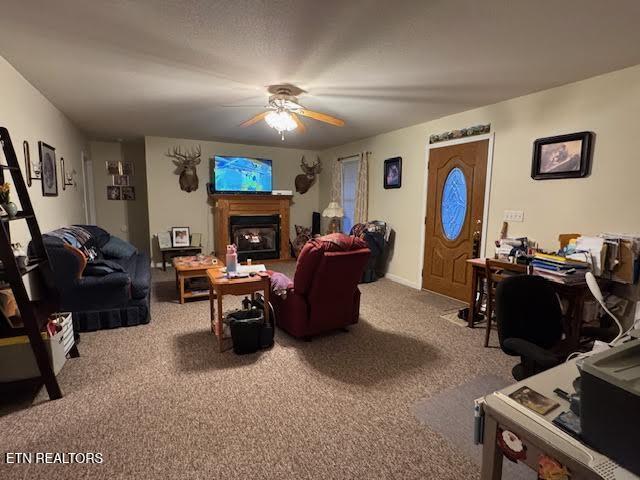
[271,233,371,338]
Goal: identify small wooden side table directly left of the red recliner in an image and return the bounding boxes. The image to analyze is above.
[207,269,271,352]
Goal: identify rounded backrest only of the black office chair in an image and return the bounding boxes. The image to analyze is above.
[495,275,562,355]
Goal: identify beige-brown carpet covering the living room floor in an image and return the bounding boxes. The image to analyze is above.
[0,264,514,480]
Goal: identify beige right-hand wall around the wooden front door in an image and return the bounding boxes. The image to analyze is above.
[321,65,640,286]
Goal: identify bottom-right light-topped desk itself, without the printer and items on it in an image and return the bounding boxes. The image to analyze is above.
[477,360,638,480]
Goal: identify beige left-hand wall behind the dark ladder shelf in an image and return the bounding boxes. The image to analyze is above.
[0,57,86,244]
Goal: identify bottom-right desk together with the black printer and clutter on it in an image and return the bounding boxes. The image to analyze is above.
[474,336,640,480]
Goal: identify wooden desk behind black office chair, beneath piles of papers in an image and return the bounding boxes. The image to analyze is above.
[467,258,589,346]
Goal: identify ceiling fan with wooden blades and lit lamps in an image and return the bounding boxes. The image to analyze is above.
[240,84,344,141]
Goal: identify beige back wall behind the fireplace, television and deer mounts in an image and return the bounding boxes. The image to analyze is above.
[145,137,322,260]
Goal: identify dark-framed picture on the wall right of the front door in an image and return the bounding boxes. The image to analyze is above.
[531,132,593,180]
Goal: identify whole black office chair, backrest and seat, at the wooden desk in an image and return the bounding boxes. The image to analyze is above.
[495,275,568,381]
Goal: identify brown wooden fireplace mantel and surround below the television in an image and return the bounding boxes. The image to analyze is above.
[209,194,293,260]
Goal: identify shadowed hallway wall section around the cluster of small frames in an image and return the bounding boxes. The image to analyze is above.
[90,139,149,252]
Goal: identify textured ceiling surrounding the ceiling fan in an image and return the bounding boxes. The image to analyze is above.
[0,0,640,148]
